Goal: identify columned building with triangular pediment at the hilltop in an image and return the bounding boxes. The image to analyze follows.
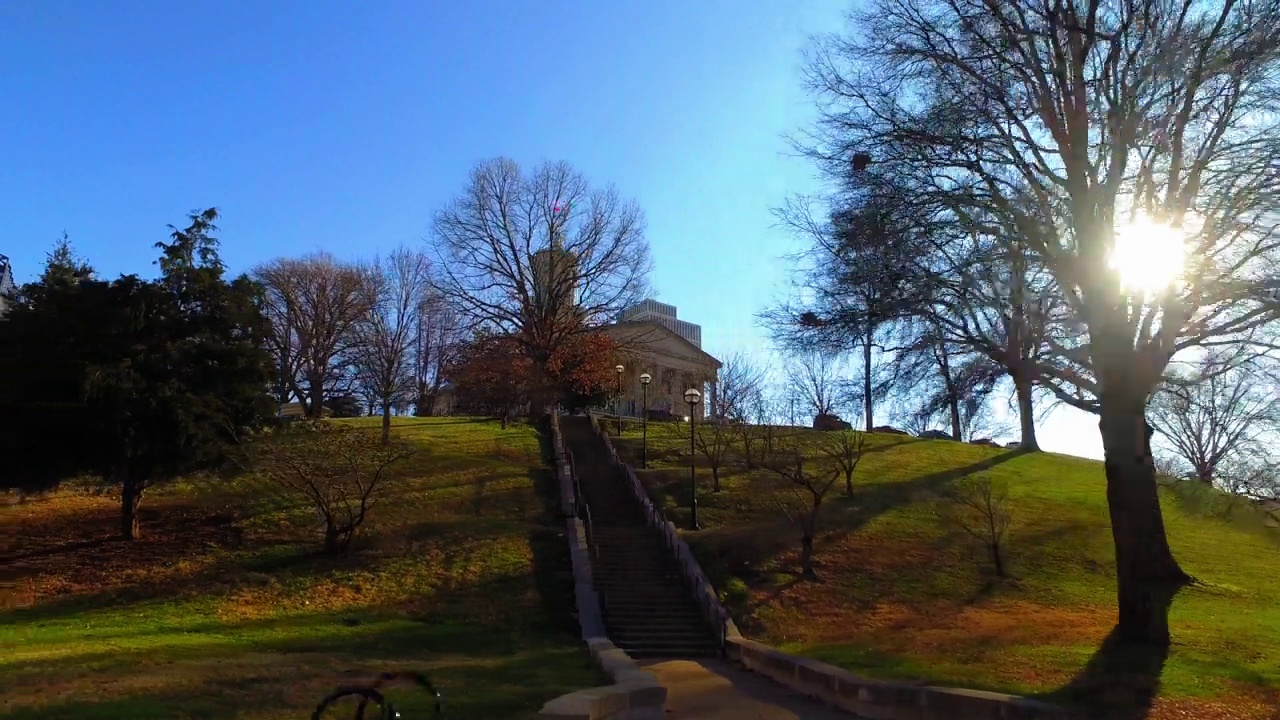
[600,300,722,418]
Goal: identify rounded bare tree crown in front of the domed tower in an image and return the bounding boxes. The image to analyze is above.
[433,158,650,407]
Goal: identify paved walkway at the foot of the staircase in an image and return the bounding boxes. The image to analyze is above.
[641,660,855,720]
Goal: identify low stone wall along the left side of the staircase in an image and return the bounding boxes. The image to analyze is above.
[538,421,667,720]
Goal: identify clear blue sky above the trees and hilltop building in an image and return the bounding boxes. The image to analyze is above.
[0,0,1101,456]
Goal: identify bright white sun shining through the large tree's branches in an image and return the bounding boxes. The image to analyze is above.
[1111,215,1187,297]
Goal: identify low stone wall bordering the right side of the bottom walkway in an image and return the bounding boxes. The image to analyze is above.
[726,637,1071,720]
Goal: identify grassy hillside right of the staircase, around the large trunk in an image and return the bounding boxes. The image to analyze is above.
[606,423,1280,719]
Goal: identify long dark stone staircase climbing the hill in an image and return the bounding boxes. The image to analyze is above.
[561,416,721,657]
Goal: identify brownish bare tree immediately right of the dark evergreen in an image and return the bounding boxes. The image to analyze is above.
[252,252,369,419]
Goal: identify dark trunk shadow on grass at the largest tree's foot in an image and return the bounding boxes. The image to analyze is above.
[1038,579,1181,720]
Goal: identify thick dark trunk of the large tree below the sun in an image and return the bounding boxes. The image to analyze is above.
[1098,404,1190,646]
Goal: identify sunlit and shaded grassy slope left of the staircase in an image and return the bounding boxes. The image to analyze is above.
[0,418,603,720]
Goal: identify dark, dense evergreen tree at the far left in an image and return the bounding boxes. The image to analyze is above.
[0,209,271,538]
